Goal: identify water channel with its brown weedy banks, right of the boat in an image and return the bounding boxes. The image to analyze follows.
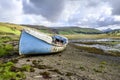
[71,38,120,57]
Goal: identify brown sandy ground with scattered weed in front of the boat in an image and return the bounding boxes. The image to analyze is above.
[6,43,120,80]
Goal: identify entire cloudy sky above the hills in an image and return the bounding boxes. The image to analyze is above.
[0,0,120,29]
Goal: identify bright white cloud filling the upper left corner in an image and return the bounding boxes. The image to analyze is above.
[0,0,22,23]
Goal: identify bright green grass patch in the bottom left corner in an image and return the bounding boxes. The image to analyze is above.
[0,62,26,80]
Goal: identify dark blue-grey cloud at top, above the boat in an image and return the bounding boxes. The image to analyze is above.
[23,0,65,21]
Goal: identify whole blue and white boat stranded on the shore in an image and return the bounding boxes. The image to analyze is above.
[19,28,68,55]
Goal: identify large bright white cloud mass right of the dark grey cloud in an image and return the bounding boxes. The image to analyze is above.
[59,0,120,28]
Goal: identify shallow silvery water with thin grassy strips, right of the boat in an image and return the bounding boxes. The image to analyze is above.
[71,38,120,52]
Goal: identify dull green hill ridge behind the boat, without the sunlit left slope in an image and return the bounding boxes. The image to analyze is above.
[22,25,102,34]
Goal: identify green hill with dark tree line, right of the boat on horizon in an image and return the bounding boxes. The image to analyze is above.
[52,27,102,34]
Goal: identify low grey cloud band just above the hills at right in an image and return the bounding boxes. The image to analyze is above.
[68,13,120,28]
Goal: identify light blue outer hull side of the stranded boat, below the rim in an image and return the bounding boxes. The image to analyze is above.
[19,30,65,55]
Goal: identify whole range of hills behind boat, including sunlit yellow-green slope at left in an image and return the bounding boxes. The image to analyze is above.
[0,22,102,35]
